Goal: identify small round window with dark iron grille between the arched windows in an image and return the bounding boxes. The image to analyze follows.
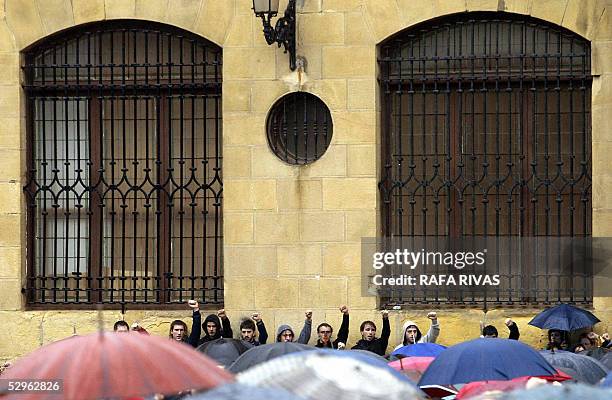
[266,92,333,165]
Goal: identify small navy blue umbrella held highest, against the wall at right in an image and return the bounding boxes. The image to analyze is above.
[529,304,600,331]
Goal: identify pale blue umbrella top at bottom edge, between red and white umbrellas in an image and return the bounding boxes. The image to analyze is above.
[185,383,303,400]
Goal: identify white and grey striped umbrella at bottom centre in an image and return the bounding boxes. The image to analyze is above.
[237,350,422,400]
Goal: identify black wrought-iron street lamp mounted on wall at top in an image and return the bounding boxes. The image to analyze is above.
[253,0,295,71]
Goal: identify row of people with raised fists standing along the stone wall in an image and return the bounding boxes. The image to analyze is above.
[114,300,612,356]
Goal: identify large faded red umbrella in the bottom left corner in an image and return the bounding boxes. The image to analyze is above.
[0,333,234,400]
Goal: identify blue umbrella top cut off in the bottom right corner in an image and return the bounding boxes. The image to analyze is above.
[470,383,612,400]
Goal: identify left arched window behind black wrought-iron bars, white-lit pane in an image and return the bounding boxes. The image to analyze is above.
[23,21,223,307]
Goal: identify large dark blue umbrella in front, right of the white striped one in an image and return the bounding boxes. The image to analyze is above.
[419,338,557,386]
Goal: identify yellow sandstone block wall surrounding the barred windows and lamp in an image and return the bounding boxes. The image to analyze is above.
[0,0,612,360]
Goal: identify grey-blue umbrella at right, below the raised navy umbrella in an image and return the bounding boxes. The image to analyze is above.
[540,350,608,385]
